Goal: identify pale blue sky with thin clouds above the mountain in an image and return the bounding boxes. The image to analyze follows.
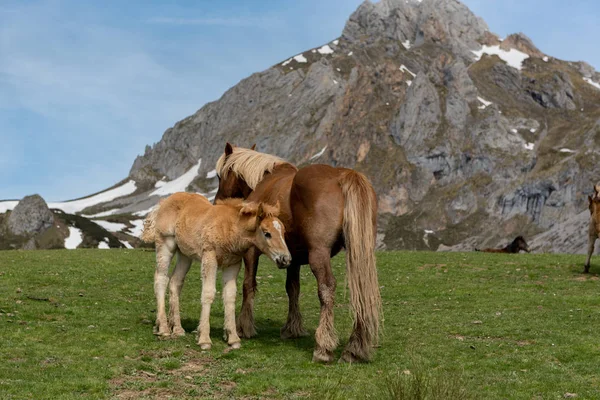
[0,0,600,201]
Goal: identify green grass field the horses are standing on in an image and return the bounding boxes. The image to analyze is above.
[0,250,600,399]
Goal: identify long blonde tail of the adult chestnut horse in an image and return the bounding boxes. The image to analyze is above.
[339,171,381,360]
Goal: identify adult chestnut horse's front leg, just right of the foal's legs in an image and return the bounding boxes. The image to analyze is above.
[237,247,261,338]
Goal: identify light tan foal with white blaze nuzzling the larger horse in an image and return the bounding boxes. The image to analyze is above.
[142,193,291,350]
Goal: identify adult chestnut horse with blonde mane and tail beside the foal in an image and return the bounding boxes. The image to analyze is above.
[215,143,381,362]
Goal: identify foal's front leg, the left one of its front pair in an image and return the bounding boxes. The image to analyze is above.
[198,251,217,350]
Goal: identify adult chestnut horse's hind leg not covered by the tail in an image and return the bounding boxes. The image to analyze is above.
[308,249,338,363]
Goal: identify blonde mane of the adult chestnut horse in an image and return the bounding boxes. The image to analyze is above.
[216,147,295,190]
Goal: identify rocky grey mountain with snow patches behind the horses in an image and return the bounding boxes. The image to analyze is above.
[5,0,600,252]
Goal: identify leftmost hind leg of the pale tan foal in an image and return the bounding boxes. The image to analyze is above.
[154,237,176,336]
